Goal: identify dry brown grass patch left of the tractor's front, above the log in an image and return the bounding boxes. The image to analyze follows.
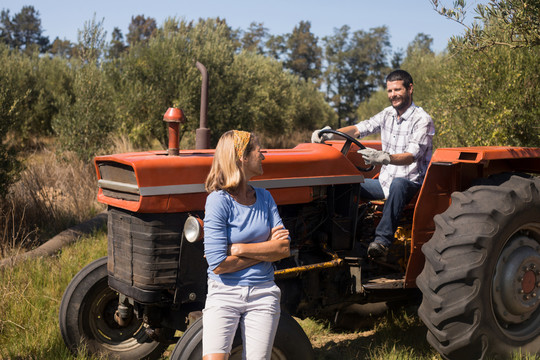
[0,149,103,258]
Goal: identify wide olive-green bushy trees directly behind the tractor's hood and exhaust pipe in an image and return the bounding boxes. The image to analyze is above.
[107,19,334,146]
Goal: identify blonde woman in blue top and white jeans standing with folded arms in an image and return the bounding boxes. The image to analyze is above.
[203,130,289,360]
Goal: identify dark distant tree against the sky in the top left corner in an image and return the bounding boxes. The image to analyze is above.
[0,6,49,53]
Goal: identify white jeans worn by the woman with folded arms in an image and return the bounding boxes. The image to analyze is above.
[203,279,281,360]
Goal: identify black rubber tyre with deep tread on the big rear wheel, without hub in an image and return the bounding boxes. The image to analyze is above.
[417,176,540,359]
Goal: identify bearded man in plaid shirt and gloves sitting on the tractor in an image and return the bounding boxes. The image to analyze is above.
[311,70,435,258]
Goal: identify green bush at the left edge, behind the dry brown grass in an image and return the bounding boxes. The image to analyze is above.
[0,44,70,197]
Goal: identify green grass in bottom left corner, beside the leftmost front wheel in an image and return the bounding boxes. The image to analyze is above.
[0,230,107,360]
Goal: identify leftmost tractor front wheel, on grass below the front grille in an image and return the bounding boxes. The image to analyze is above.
[59,257,168,360]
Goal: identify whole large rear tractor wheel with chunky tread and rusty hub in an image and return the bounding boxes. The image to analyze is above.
[417,176,540,359]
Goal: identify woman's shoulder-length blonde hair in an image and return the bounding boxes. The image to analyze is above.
[204,130,254,193]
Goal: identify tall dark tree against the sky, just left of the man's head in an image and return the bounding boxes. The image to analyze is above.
[323,25,390,126]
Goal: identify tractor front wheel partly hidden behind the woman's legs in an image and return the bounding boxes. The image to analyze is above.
[170,313,314,360]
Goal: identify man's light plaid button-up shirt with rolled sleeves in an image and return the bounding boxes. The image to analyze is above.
[356,103,435,197]
